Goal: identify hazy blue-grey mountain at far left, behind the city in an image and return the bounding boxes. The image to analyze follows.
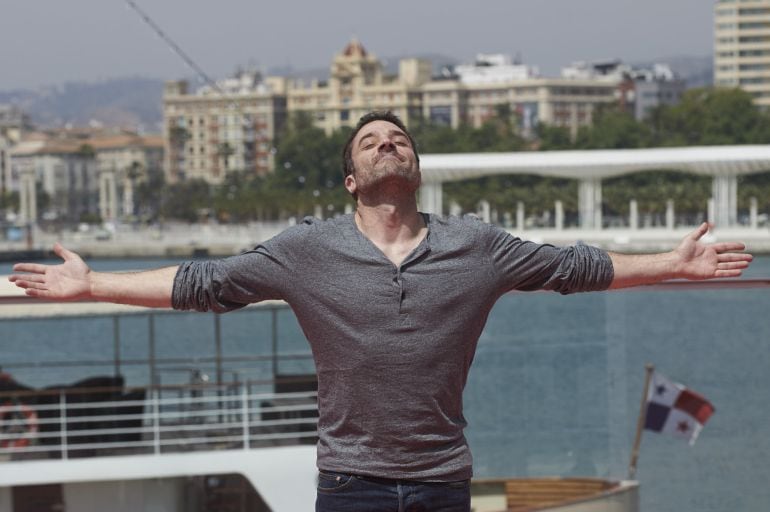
[0,77,163,133]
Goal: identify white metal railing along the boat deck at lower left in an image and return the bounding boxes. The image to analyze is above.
[0,383,318,460]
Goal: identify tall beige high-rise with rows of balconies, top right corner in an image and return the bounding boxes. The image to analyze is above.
[714,0,770,108]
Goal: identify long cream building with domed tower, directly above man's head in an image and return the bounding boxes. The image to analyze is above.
[288,43,619,136]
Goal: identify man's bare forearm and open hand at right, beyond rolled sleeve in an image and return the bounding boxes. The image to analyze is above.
[610,222,752,288]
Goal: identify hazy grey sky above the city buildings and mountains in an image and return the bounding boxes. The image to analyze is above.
[0,0,714,91]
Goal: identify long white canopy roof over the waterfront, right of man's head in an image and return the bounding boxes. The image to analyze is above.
[420,145,770,183]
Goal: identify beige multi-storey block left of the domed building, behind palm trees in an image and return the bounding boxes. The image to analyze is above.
[163,71,286,184]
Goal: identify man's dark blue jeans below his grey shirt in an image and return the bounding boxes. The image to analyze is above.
[315,471,471,512]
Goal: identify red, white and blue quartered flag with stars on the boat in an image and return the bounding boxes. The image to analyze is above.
[644,372,714,445]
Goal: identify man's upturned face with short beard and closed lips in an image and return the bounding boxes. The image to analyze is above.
[345,121,421,199]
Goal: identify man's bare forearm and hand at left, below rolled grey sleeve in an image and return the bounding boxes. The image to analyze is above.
[8,243,177,308]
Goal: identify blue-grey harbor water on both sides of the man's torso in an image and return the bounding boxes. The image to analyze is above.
[0,256,770,512]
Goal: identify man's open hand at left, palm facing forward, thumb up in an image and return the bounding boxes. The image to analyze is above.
[8,243,91,300]
